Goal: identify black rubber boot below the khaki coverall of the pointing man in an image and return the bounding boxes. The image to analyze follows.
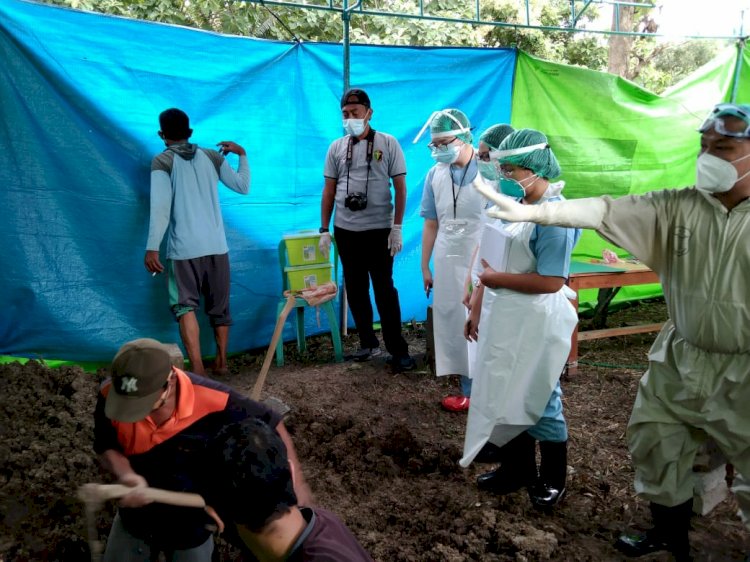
[615,499,693,562]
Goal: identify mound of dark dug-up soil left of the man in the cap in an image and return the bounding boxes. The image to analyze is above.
[0,362,114,560]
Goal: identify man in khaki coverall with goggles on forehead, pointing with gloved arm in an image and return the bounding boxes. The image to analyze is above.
[477,103,750,561]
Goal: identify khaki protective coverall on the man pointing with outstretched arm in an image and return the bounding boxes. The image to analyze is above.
[596,189,750,524]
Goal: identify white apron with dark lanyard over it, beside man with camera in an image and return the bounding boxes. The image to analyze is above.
[432,160,487,376]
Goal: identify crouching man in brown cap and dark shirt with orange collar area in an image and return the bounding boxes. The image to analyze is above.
[94,338,312,562]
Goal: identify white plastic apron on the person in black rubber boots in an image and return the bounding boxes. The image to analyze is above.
[459,182,578,467]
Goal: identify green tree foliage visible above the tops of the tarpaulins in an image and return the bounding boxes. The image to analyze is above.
[39,0,720,92]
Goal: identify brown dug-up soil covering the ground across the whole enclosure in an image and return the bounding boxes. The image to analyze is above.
[0,302,750,562]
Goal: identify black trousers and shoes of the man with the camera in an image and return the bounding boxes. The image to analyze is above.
[333,227,409,357]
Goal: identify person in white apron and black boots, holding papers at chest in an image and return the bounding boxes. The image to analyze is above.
[461,129,580,508]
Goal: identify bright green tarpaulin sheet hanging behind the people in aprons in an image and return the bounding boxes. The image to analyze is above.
[511,48,750,311]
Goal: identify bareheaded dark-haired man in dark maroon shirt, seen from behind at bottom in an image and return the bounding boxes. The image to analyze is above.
[203,418,372,562]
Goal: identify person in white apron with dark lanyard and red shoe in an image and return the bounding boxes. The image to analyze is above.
[415,109,513,412]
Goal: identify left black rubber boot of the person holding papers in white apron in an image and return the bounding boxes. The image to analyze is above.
[477,431,537,495]
